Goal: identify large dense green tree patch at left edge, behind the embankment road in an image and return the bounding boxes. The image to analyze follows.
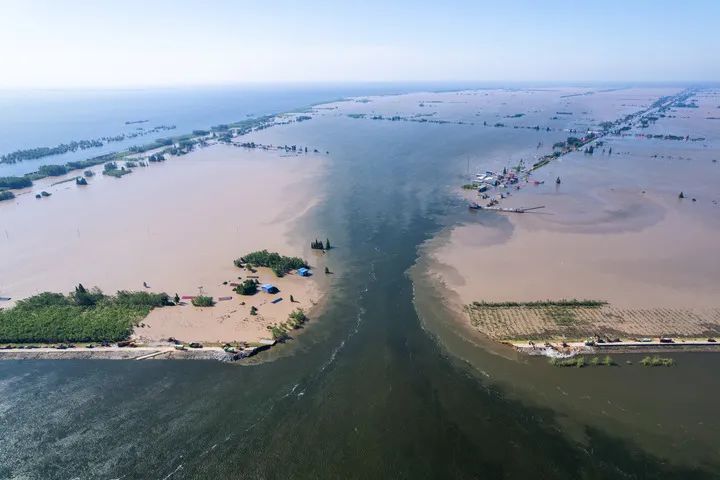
[0,284,171,343]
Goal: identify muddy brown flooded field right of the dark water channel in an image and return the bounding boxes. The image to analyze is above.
[416,89,720,340]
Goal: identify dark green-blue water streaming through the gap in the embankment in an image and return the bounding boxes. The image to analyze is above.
[0,92,718,479]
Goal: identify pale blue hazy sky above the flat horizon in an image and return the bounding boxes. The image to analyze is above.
[0,0,720,88]
